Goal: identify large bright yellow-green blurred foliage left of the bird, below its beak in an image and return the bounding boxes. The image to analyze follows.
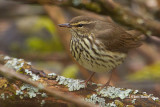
[26,17,63,53]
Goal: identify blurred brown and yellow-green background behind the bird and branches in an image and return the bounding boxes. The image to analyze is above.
[0,0,160,97]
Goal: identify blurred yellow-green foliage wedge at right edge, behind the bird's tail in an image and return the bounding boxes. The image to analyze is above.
[127,62,160,81]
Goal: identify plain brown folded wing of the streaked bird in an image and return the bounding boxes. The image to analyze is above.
[96,24,141,53]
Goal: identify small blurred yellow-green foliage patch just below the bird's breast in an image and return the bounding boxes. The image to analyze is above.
[62,65,78,78]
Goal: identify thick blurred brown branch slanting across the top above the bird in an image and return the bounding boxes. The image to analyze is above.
[13,0,160,37]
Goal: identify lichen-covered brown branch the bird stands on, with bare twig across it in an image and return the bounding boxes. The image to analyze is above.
[0,55,160,107]
